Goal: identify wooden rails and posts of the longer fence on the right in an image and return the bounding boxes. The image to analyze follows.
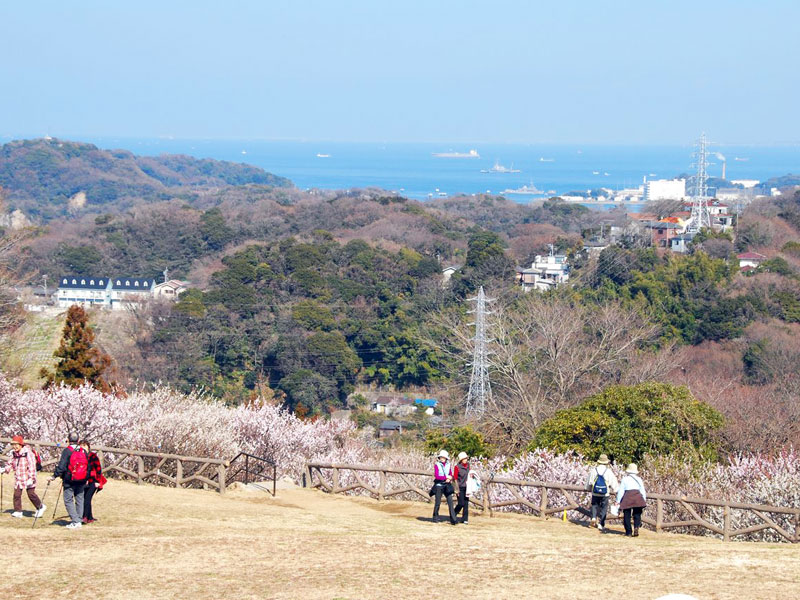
[304,461,800,543]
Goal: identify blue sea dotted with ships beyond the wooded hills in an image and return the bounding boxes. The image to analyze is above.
[87,138,800,202]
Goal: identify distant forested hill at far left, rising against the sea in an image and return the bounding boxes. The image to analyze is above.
[0,138,292,222]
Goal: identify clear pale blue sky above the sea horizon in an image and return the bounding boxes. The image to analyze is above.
[0,0,800,144]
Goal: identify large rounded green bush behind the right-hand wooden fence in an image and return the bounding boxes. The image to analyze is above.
[530,383,723,463]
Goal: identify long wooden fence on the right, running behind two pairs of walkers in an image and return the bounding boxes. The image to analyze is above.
[304,462,800,543]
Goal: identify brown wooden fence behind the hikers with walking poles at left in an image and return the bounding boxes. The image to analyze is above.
[0,438,229,494]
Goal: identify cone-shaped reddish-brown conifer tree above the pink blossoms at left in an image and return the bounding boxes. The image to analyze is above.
[41,304,112,393]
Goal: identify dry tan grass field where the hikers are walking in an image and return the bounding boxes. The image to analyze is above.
[0,476,800,600]
